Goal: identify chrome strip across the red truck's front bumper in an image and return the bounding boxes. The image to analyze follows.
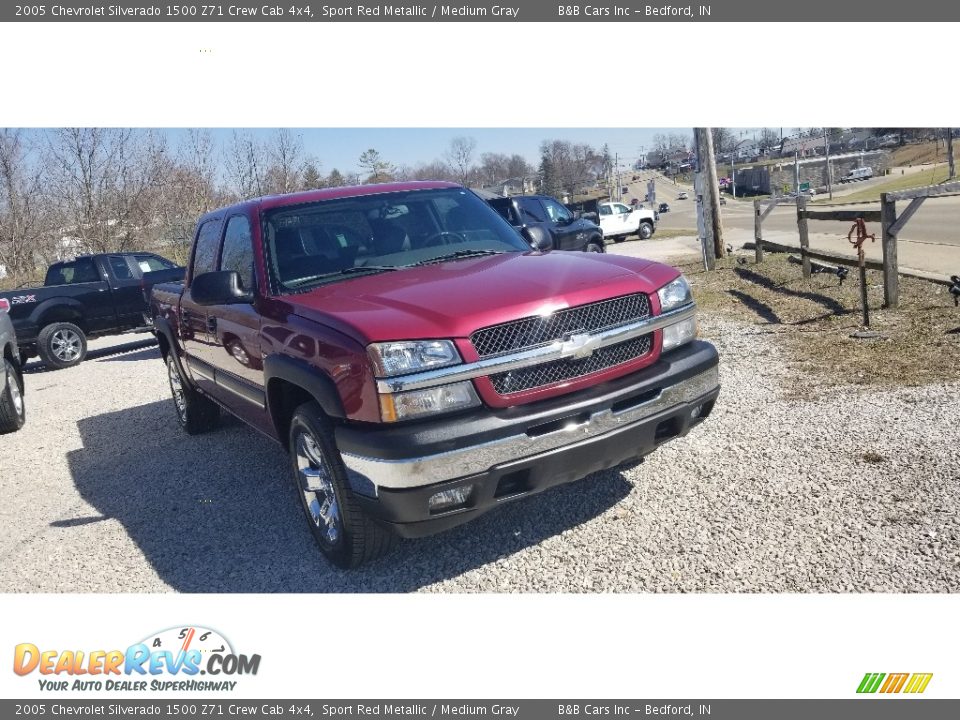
[342,367,720,488]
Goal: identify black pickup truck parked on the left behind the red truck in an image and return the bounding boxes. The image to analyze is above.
[0,252,183,368]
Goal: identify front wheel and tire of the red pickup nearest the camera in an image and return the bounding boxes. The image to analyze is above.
[289,402,396,569]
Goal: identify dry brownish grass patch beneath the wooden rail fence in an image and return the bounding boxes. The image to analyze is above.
[677,254,960,394]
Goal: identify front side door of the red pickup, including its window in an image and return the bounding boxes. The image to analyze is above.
[206,215,266,421]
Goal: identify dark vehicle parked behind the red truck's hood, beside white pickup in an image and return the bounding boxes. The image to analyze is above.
[487,195,606,252]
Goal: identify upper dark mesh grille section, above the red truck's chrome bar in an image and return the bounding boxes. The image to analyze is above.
[470,293,650,358]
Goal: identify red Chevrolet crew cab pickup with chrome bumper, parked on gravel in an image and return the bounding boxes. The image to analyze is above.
[151,182,719,567]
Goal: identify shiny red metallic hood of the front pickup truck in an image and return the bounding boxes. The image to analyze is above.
[283,252,679,344]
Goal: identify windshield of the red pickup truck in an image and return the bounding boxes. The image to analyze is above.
[264,188,530,293]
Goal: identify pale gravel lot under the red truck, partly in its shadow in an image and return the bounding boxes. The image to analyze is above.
[0,318,960,592]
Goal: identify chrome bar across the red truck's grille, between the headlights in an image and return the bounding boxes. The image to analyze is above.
[377,304,696,394]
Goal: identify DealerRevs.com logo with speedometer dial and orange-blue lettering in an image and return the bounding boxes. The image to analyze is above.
[13,626,260,692]
